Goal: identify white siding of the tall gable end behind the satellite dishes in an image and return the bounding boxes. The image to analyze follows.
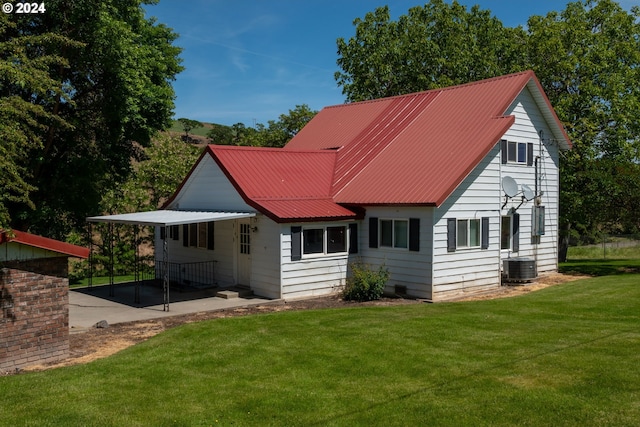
[502,89,559,273]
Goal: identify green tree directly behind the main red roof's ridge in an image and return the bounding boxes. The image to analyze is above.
[335,0,525,102]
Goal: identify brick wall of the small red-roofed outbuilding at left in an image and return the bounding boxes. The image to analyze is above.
[0,257,69,372]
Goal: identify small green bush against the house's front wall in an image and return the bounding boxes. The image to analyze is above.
[342,263,389,301]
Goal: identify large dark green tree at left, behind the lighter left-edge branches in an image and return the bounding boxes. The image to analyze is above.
[2,0,182,237]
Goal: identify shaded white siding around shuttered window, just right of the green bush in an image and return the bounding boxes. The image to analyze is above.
[359,206,433,299]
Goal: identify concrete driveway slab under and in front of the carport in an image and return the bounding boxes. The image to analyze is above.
[69,283,274,332]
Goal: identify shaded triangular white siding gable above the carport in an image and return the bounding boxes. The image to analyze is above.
[168,155,255,212]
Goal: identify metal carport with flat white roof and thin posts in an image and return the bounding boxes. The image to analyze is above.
[87,210,256,311]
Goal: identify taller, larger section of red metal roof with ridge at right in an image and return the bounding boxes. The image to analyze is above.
[285,71,570,206]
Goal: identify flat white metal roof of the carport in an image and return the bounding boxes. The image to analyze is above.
[87,209,256,227]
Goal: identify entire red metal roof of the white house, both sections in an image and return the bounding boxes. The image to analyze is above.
[167,71,571,222]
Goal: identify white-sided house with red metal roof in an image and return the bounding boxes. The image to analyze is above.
[89,71,571,301]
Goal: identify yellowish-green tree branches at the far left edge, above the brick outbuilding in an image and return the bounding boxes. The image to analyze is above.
[0,14,78,230]
